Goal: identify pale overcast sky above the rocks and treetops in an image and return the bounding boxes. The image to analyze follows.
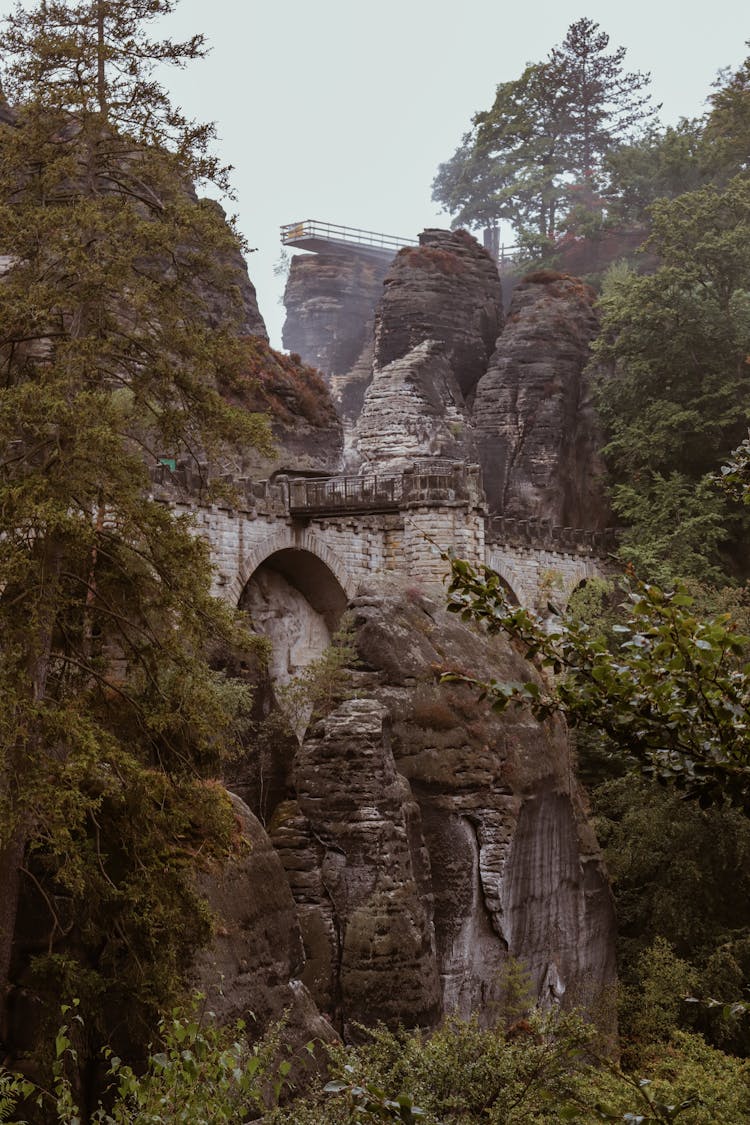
[7,0,750,347]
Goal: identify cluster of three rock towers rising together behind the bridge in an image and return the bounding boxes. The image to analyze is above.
[284,230,609,530]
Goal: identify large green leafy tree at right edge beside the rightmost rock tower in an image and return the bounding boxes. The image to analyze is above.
[594,177,750,583]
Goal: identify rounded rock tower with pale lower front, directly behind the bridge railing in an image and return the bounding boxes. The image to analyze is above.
[350,231,503,471]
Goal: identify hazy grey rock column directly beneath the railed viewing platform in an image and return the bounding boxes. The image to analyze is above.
[282,253,388,376]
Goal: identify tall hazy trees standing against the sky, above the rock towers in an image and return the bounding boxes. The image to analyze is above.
[433,18,653,253]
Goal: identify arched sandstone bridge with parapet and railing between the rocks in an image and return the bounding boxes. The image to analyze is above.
[154,460,614,628]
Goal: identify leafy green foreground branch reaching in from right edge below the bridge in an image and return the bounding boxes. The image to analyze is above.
[445,559,750,812]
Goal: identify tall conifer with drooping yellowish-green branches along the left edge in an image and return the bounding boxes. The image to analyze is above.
[0,0,270,1053]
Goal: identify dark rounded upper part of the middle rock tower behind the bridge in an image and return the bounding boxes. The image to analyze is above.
[374,230,503,397]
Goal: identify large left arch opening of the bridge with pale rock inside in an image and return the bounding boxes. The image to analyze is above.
[240,547,347,685]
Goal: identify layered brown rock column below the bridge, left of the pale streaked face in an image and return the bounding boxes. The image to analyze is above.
[271,699,441,1034]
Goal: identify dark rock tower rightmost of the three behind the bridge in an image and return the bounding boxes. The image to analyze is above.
[473,271,607,529]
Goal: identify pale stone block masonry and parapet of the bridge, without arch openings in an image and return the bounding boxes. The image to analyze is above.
[154,465,606,609]
